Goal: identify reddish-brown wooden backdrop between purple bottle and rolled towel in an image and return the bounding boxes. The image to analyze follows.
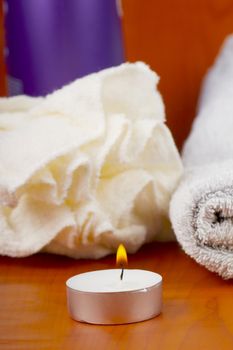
[122,0,233,147]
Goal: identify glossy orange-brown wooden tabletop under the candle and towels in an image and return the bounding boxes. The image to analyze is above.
[0,243,233,350]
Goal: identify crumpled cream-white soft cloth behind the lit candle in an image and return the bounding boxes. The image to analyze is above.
[0,63,182,258]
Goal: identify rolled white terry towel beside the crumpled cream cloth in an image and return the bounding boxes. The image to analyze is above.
[170,36,233,278]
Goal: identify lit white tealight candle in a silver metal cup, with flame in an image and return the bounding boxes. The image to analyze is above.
[66,246,162,324]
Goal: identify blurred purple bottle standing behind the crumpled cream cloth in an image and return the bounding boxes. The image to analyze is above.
[5,0,124,96]
